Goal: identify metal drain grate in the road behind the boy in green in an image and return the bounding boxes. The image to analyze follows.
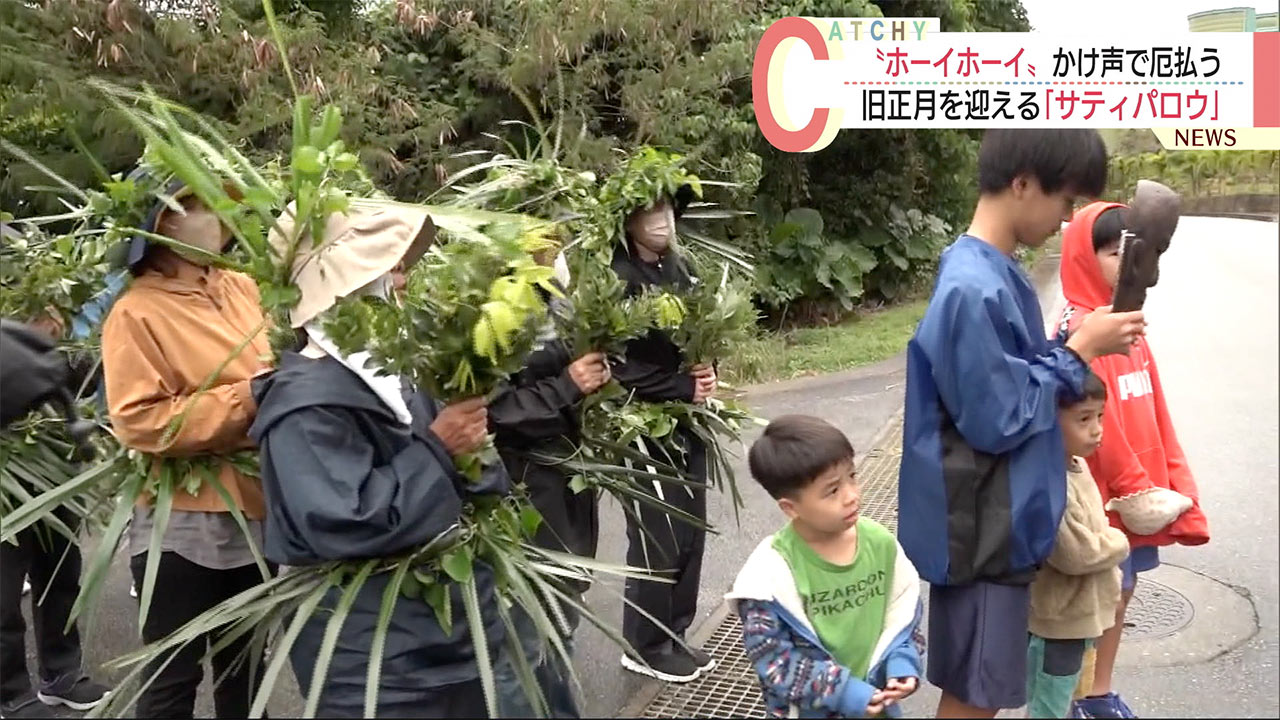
[640,418,902,717]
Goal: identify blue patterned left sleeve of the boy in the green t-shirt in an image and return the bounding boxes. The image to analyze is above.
[739,600,877,717]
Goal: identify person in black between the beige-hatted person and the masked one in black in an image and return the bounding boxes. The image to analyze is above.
[489,249,611,717]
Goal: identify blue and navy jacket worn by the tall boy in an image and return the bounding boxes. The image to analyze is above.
[897,236,1087,585]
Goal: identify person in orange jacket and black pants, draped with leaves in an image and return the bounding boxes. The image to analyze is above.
[102,183,269,717]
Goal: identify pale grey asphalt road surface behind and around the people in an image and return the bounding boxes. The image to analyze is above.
[12,218,1280,717]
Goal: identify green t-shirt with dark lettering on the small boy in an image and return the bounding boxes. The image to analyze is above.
[773,518,897,678]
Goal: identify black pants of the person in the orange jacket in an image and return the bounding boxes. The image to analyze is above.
[129,552,268,717]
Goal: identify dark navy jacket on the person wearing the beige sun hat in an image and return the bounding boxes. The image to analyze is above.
[250,352,506,702]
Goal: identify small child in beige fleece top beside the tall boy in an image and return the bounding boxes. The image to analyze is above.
[1027,373,1129,717]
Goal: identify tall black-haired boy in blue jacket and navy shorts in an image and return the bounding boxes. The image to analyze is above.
[899,129,1143,717]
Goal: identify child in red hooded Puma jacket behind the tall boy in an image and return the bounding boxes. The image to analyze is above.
[1059,202,1208,717]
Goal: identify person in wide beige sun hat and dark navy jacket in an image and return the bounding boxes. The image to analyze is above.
[251,205,509,717]
